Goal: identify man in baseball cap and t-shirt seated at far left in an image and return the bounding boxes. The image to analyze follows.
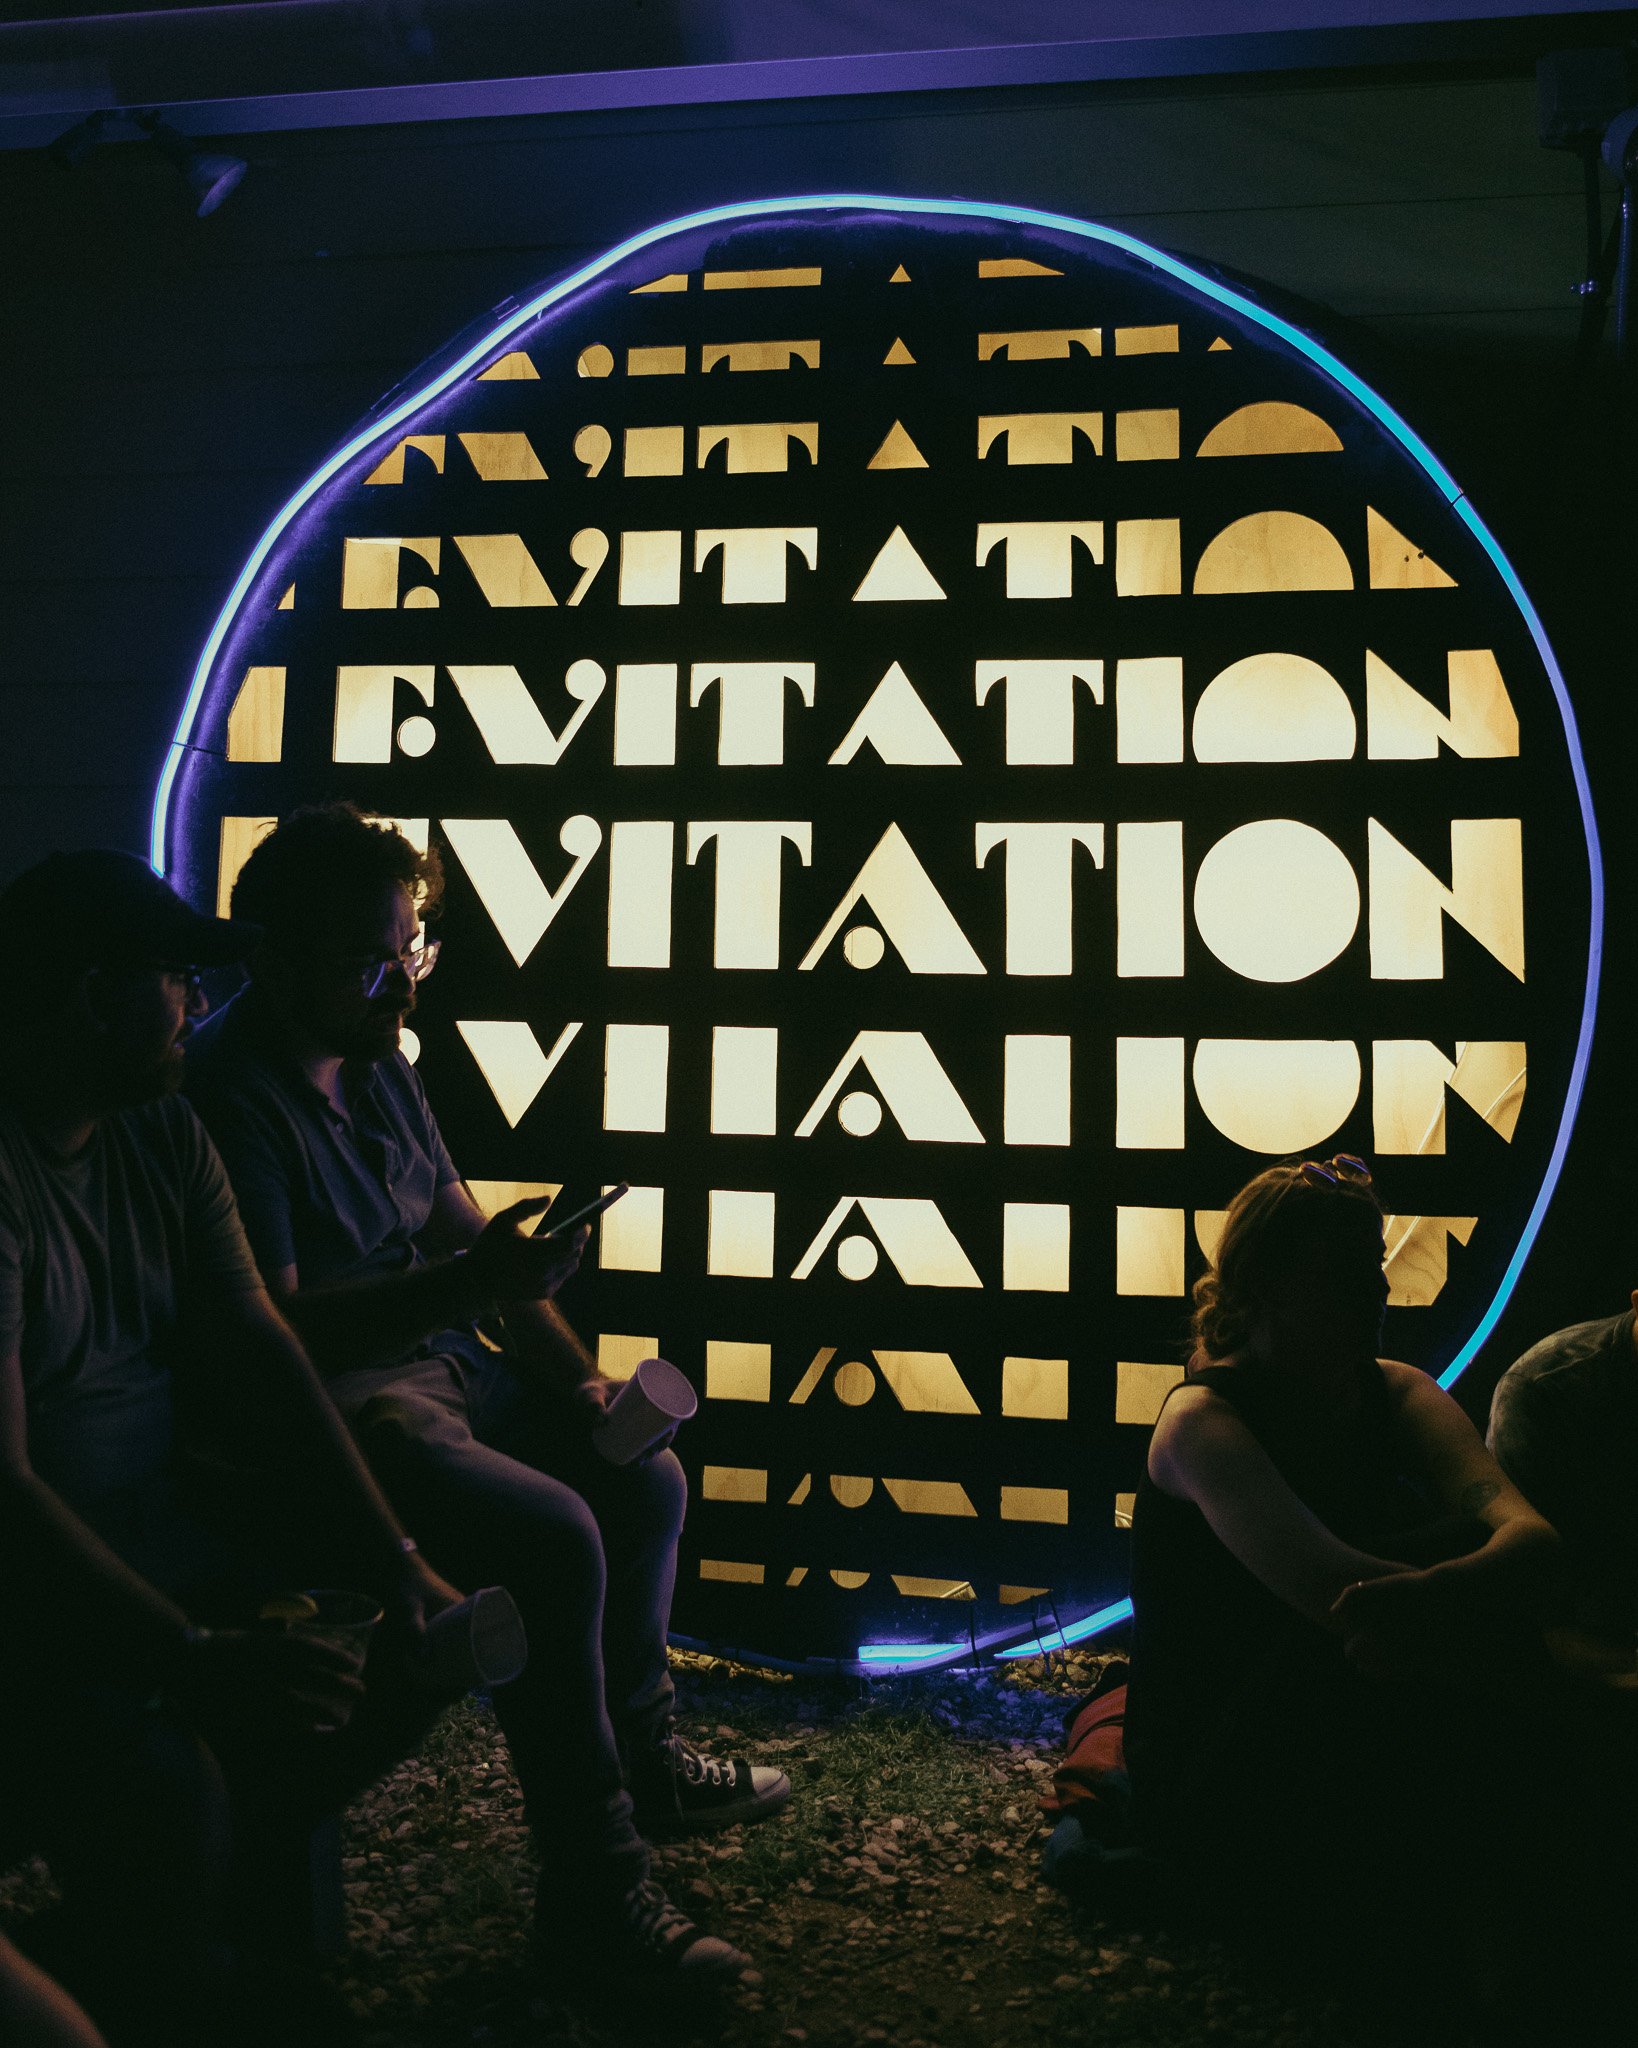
[0,850,461,2044]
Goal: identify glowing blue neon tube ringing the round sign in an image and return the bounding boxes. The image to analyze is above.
[162,193,1603,1663]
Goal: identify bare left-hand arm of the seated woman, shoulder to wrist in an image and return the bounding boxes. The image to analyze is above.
[1149,1386,1409,1628]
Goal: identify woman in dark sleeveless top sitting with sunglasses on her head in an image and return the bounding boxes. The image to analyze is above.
[1126,1155,1558,2023]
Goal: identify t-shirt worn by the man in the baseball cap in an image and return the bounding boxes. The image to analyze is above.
[0,1096,260,1520]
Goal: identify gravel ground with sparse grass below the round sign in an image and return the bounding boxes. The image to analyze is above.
[0,1657,1449,2048]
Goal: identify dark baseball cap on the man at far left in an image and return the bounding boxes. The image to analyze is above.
[0,846,262,967]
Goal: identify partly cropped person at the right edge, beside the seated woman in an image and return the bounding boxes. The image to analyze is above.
[1491,1292,1638,1667]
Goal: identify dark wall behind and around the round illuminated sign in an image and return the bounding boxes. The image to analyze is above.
[0,56,1638,1407]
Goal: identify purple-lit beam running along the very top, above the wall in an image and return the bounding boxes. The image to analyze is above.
[0,0,1638,150]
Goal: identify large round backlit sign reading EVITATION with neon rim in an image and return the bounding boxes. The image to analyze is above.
[154,197,1599,1659]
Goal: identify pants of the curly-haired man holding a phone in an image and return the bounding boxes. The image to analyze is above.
[330,1358,688,1913]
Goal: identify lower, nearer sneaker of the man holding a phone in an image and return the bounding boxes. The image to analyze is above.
[534,1878,760,2001]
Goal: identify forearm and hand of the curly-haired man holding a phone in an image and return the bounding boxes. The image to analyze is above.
[266,1182,590,1378]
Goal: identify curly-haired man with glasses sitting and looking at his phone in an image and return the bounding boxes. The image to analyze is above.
[188,805,790,1989]
